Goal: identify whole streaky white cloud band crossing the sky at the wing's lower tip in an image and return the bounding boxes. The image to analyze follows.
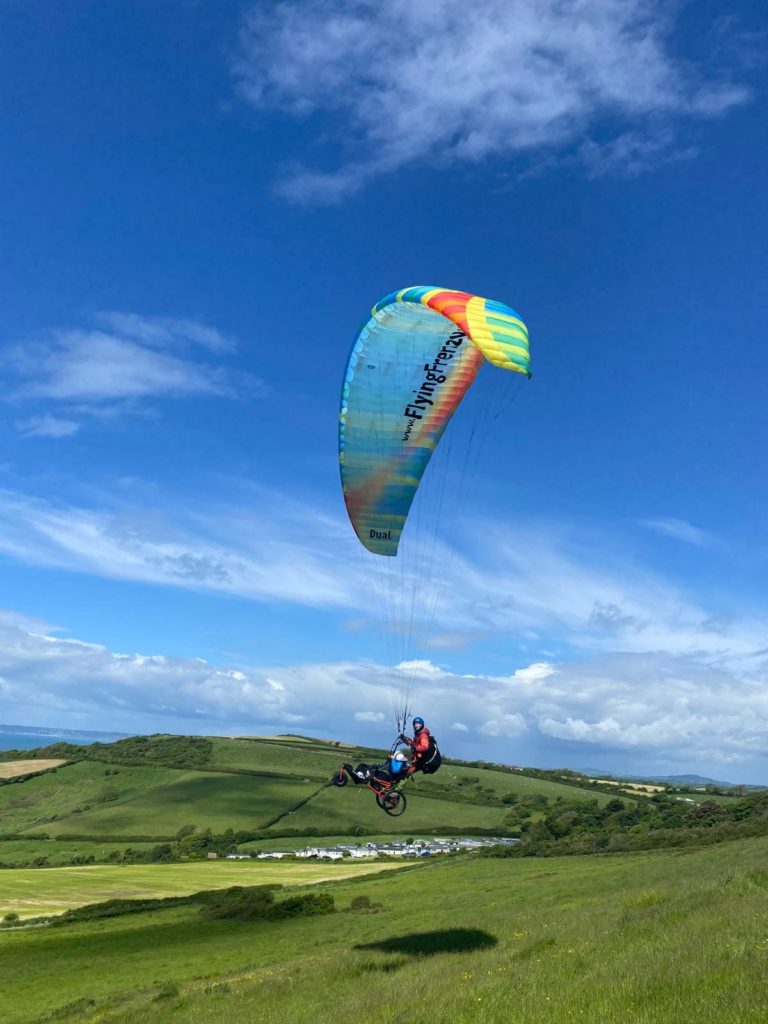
[0,481,768,671]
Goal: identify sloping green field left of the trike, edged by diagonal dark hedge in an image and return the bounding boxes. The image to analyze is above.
[25,763,318,838]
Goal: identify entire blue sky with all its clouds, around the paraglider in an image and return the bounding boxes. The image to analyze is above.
[0,0,768,781]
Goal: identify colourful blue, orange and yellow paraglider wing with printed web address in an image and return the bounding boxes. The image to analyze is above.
[339,287,530,555]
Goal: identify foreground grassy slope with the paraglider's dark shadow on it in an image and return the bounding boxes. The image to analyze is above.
[0,838,768,1024]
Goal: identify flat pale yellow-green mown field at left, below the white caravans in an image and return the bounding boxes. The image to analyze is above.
[0,860,409,919]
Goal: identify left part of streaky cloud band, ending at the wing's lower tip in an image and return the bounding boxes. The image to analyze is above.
[0,492,362,607]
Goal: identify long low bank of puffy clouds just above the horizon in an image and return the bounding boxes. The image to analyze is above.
[0,612,768,771]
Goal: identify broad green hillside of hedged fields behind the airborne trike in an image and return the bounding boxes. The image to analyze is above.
[0,735,626,863]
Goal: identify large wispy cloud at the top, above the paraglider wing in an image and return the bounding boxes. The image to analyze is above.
[233,0,748,202]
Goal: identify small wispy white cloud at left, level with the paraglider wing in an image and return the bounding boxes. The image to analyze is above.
[2,312,249,437]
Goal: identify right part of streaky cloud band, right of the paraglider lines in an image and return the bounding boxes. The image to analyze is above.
[451,524,768,665]
